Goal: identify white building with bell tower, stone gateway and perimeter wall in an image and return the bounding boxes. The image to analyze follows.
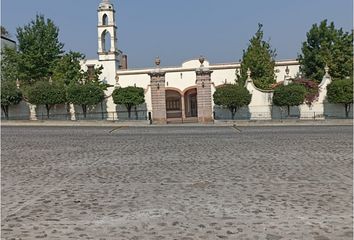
[2,0,352,120]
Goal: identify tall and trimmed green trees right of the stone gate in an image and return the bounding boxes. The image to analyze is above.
[214,20,353,118]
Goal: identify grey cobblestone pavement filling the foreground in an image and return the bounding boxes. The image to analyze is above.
[1,126,353,240]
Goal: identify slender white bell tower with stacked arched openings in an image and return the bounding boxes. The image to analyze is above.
[97,0,120,63]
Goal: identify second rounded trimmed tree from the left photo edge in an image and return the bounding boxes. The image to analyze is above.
[25,81,66,119]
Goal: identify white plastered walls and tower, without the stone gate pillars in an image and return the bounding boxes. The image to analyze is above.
[75,0,352,122]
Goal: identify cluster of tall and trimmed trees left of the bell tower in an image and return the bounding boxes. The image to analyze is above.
[1,15,109,118]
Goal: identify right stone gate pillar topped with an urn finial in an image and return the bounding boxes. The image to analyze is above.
[196,57,214,123]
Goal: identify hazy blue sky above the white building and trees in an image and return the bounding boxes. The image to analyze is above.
[1,0,353,68]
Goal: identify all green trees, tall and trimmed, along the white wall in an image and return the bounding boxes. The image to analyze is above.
[1,15,353,119]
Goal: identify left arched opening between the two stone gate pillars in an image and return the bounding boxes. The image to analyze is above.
[166,90,182,118]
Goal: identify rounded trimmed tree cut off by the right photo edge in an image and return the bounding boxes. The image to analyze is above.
[327,78,353,118]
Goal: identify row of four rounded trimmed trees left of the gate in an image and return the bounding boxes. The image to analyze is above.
[1,77,145,119]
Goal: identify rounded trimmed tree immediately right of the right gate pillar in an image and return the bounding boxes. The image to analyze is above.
[213,84,252,119]
